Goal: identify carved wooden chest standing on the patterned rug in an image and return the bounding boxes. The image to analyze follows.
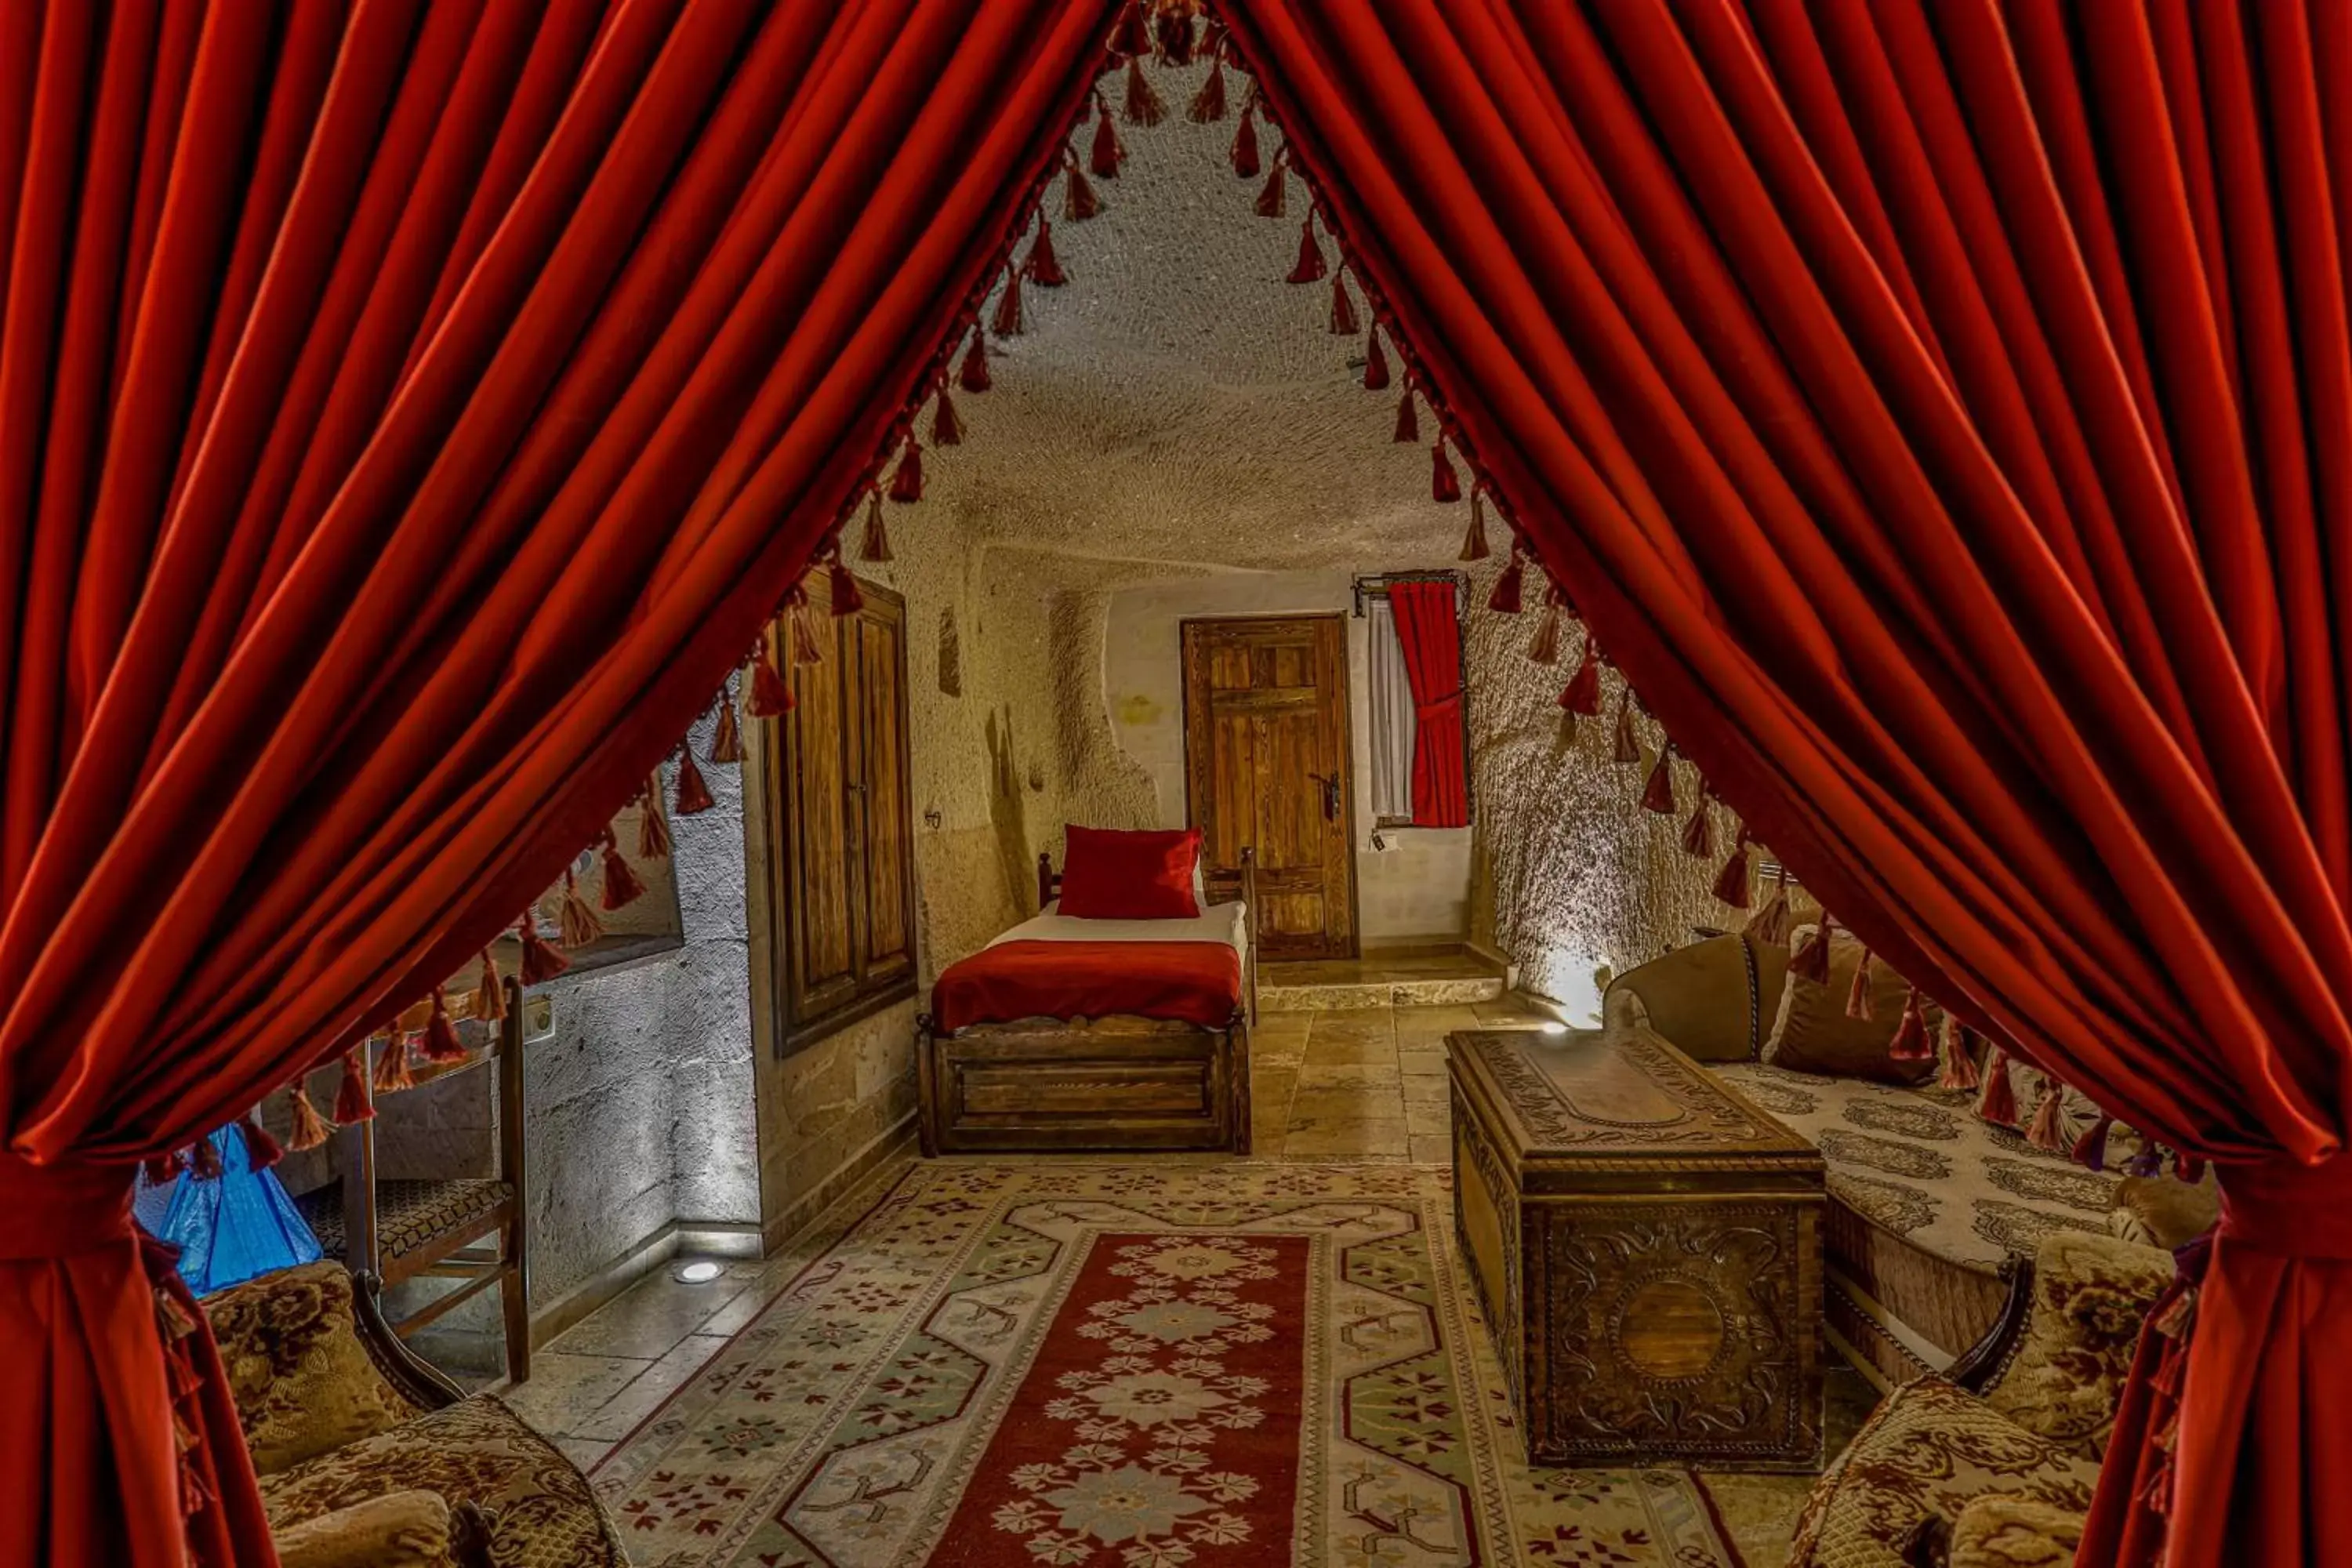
[1446,1029,1825,1469]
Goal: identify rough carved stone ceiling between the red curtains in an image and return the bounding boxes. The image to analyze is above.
[917,68,1465,576]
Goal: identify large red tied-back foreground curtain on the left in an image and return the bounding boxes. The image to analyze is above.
[0,0,1110,1568]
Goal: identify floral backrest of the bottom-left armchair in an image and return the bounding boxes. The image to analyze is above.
[205,1262,416,1476]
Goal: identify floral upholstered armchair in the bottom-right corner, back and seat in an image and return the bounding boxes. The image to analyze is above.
[1788,1232,2173,1568]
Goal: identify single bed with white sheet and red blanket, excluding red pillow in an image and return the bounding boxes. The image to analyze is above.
[915,848,1258,1154]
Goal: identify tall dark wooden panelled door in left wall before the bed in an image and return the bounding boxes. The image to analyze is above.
[762,572,915,1053]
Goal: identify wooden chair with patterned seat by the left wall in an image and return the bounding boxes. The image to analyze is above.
[294,975,532,1382]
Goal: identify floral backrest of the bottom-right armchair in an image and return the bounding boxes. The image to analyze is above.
[1985,1232,2173,1460]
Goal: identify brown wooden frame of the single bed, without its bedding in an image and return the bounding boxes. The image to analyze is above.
[915,848,1261,1154]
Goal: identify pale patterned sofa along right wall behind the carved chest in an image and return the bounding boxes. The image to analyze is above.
[1604,933,2216,1389]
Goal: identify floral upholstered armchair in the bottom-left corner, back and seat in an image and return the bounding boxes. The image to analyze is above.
[205,1262,628,1568]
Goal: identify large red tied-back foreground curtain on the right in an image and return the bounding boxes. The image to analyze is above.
[1228,0,2352,1568]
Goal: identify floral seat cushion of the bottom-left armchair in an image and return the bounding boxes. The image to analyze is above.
[261,1394,628,1568]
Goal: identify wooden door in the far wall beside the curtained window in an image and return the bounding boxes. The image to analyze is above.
[1183,616,1357,959]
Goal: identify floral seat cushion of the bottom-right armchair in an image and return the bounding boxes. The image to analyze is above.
[1788,1377,2098,1568]
